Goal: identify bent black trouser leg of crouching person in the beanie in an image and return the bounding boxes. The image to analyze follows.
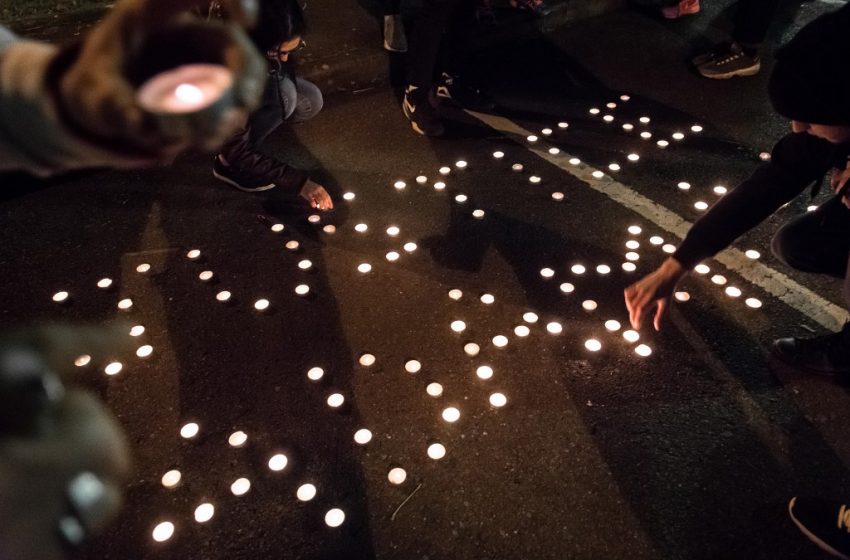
[771,196,850,308]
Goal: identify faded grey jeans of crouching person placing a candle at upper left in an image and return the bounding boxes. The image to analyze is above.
[221,74,324,164]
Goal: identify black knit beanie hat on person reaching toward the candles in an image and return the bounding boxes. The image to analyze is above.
[768,4,850,125]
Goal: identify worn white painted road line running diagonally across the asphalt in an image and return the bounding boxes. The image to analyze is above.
[467,111,850,331]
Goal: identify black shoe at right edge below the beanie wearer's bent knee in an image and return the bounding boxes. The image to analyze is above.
[771,323,850,376]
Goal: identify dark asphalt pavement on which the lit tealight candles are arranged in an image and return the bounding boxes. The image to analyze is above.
[0,0,850,560]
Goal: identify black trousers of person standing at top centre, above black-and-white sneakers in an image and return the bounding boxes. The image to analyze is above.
[407,0,477,89]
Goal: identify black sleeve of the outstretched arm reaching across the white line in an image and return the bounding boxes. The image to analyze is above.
[673,133,836,268]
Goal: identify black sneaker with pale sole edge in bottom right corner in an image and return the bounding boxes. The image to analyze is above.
[788,498,850,560]
